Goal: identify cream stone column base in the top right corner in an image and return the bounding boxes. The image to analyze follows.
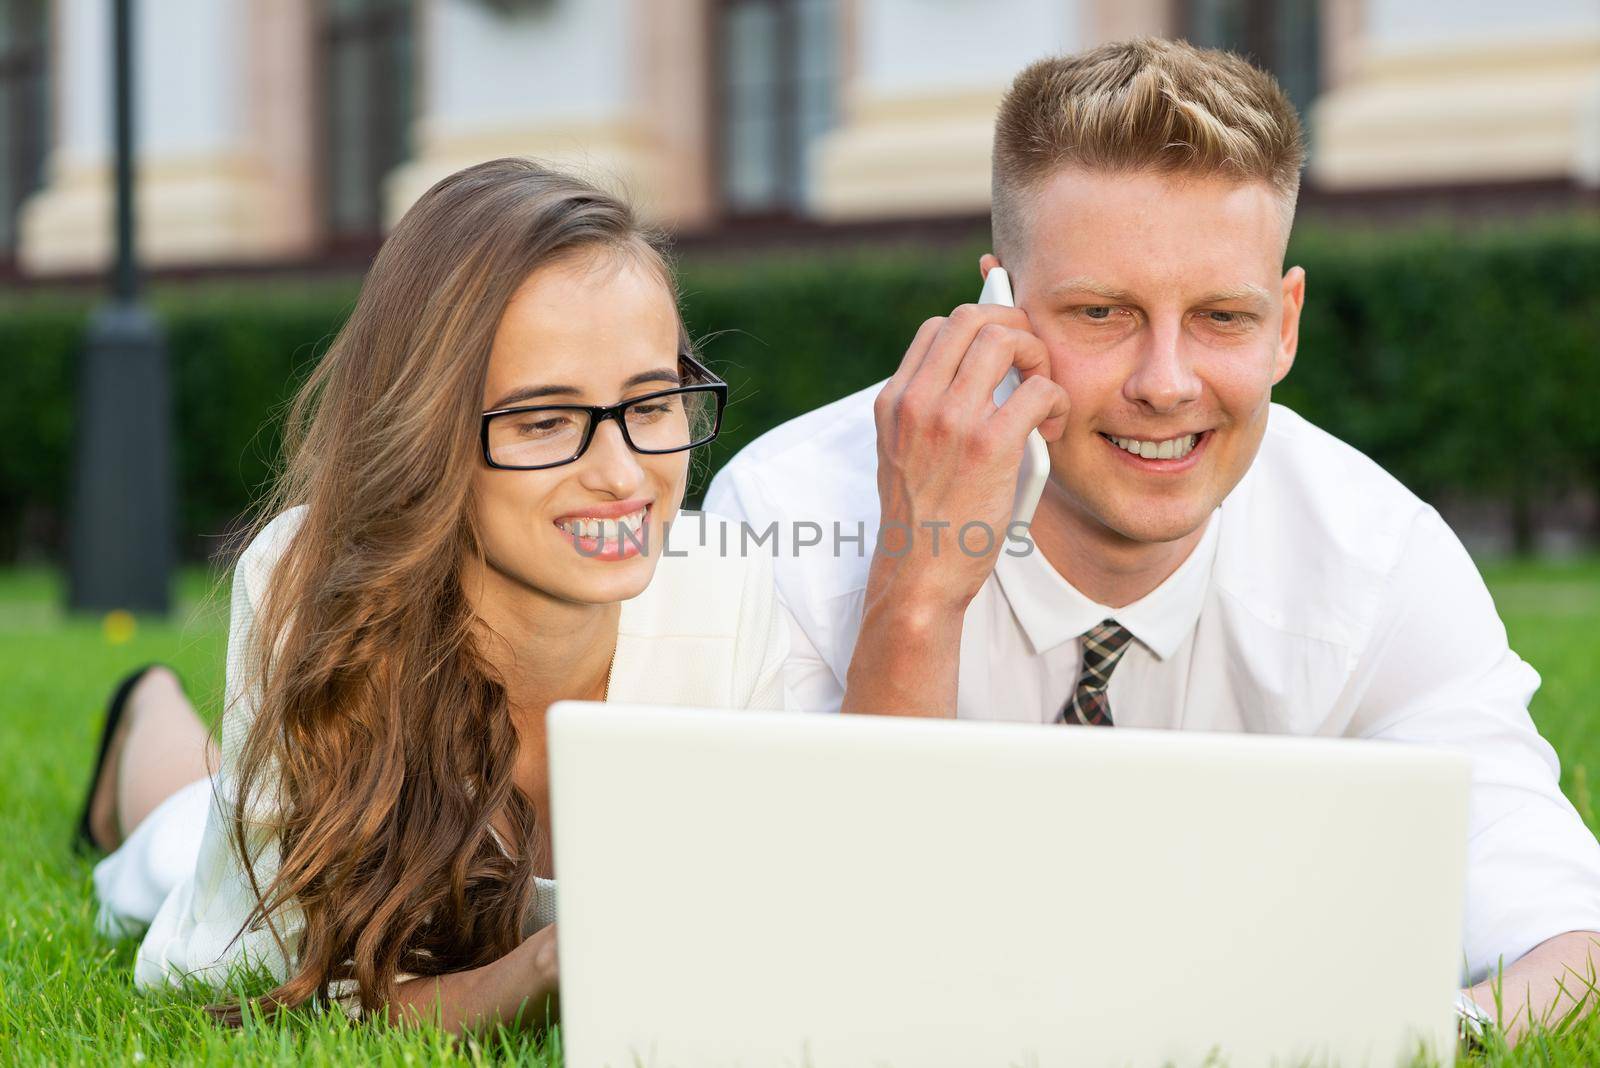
[1310,0,1600,190]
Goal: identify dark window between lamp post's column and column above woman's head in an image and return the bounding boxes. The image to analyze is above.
[318,0,413,245]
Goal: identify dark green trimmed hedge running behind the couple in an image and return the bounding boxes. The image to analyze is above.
[0,219,1600,560]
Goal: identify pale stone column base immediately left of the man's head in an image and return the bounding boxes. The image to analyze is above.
[811,0,1099,219]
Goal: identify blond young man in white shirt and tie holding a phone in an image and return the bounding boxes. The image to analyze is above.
[707,40,1600,1034]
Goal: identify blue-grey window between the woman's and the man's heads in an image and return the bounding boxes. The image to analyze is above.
[714,0,838,216]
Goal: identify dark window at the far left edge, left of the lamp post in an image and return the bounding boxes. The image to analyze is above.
[0,0,50,261]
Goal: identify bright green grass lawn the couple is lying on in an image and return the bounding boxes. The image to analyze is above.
[0,560,1600,1066]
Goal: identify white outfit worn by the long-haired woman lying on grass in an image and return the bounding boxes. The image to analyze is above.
[94,508,789,986]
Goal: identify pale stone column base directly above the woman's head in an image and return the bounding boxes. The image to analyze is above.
[386,0,710,225]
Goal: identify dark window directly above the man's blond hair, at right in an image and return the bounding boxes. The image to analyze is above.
[1186,0,1322,118]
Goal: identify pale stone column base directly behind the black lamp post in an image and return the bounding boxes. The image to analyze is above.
[18,0,317,275]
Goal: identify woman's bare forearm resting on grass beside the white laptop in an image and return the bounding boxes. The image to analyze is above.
[386,924,560,1034]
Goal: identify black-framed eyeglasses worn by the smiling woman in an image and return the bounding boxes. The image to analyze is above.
[482,353,728,472]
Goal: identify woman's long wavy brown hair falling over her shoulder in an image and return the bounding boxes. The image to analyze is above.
[204,160,682,1023]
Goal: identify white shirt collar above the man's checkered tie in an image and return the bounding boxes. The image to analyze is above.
[995,512,1221,660]
